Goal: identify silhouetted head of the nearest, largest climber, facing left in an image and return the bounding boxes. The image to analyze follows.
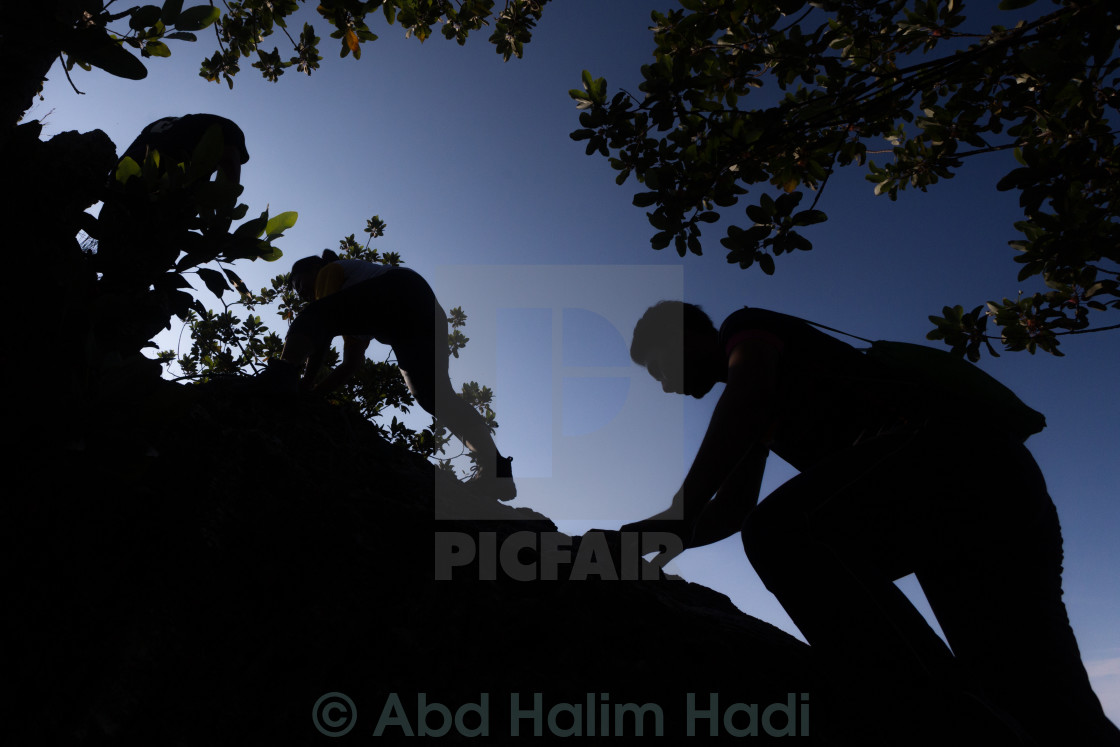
[631,301,727,399]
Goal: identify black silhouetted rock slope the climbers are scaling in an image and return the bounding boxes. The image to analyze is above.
[13,383,811,745]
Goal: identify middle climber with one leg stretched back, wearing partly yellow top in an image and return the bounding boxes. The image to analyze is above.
[262,250,516,501]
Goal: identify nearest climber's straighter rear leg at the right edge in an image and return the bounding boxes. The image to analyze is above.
[917,445,1120,746]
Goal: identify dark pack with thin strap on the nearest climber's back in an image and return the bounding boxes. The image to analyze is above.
[804,319,1046,442]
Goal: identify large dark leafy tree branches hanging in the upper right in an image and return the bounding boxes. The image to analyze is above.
[570,0,1120,353]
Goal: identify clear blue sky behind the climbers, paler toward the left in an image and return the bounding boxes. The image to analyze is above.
[29,0,1120,721]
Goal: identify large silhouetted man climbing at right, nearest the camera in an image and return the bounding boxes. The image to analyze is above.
[622,301,1120,745]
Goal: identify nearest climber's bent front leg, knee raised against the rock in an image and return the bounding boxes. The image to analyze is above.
[743,425,1034,744]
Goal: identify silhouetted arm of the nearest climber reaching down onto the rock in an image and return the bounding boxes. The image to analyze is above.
[622,338,778,547]
